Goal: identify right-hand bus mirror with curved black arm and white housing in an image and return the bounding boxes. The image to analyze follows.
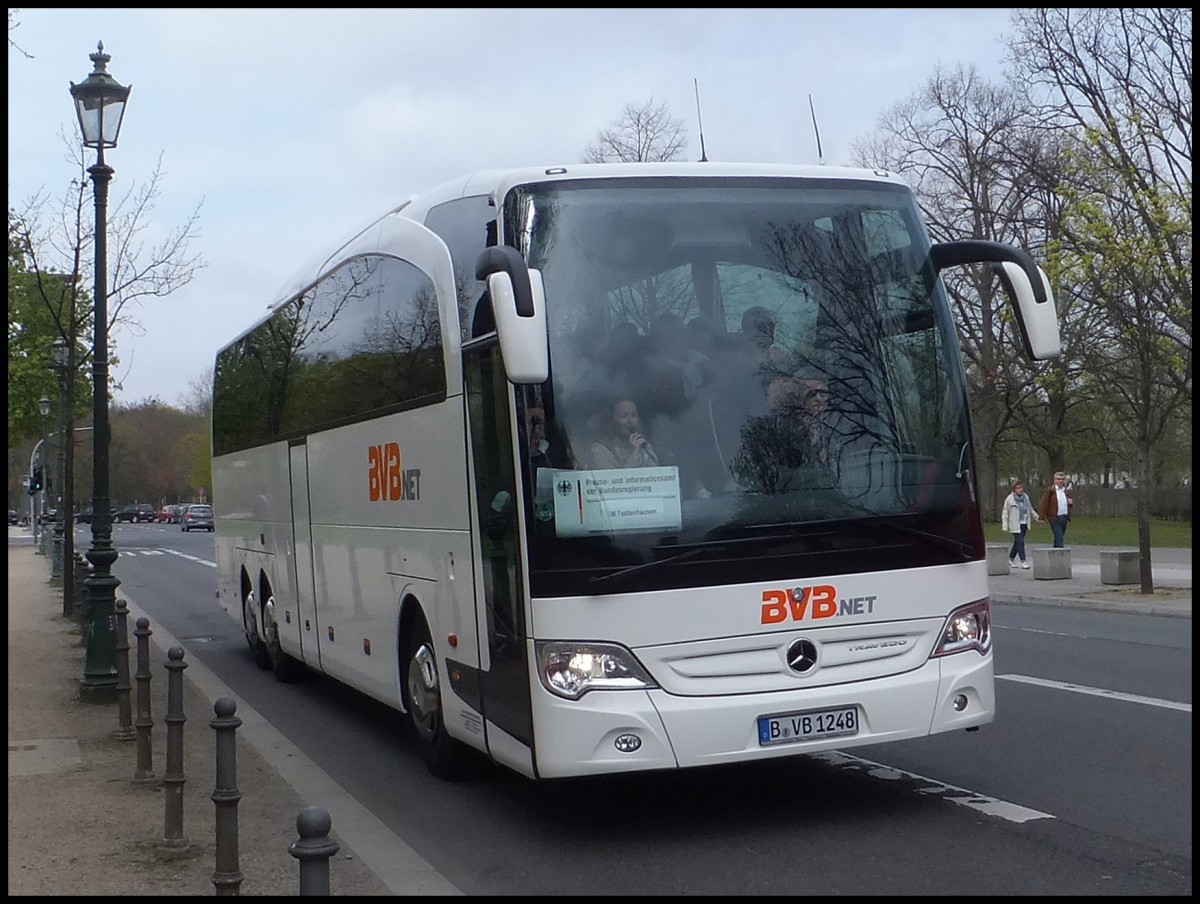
[929,239,1062,361]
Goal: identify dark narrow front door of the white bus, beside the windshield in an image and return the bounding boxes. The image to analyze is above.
[463,335,533,774]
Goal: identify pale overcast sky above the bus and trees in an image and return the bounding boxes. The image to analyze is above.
[8,7,1009,405]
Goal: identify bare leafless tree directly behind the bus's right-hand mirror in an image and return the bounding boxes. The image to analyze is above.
[853,66,1067,517]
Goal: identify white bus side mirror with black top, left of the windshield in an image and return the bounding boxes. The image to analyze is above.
[475,245,550,383]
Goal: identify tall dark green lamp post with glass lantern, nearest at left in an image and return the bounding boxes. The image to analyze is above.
[71,42,130,704]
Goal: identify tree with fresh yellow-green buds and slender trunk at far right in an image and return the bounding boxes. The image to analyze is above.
[1013,7,1192,593]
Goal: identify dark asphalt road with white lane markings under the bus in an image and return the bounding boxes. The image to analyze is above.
[84,525,1192,894]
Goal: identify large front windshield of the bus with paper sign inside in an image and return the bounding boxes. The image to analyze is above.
[503,178,983,597]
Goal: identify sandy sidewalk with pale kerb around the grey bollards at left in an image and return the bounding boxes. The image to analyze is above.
[8,527,457,896]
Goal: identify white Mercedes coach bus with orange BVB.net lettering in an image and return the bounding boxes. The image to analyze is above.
[212,163,1058,778]
